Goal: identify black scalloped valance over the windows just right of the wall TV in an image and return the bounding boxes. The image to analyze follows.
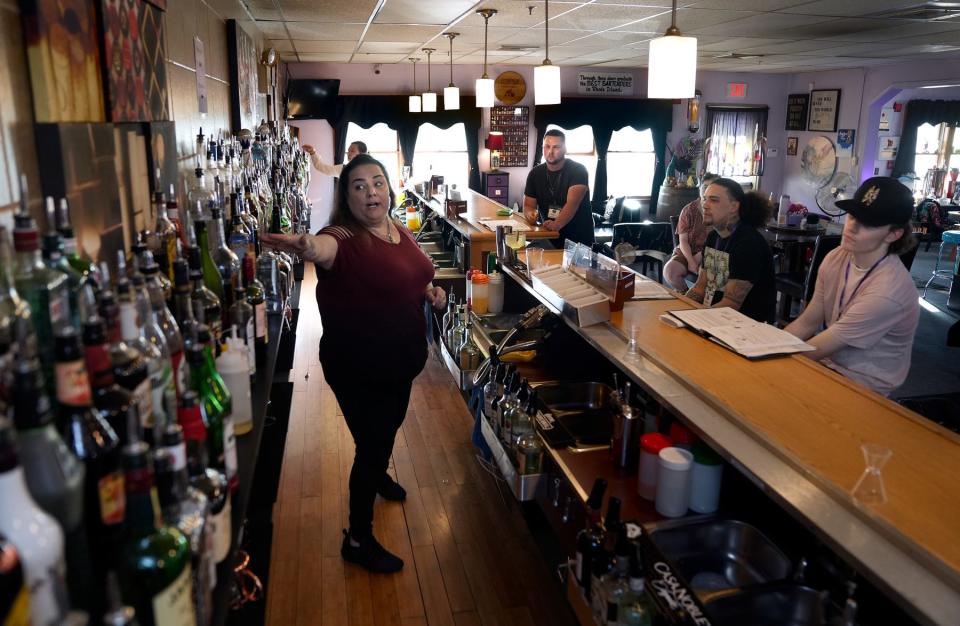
[329,96,481,192]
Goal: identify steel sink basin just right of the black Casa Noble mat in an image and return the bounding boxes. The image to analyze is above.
[650,520,792,595]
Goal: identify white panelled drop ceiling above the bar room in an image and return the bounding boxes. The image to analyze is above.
[242,0,960,73]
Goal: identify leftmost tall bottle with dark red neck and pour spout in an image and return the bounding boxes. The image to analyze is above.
[13,190,70,394]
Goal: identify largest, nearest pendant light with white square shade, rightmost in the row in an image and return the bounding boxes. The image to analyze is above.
[647,0,697,100]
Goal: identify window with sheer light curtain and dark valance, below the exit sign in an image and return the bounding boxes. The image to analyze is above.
[707,107,767,178]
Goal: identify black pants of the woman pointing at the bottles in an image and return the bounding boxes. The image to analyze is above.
[327,378,413,539]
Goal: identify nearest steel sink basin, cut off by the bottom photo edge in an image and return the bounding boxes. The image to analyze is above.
[704,584,826,626]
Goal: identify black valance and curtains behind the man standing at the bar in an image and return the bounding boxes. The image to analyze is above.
[534,98,673,207]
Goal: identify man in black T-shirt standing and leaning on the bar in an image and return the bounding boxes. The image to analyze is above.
[523,129,593,248]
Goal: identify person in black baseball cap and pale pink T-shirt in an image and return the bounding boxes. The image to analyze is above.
[786,176,920,395]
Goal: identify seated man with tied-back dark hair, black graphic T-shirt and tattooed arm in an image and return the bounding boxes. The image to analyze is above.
[687,178,777,322]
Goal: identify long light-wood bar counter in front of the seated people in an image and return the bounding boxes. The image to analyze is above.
[504,251,960,624]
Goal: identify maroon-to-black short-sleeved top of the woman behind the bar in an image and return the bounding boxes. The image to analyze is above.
[316,224,433,380]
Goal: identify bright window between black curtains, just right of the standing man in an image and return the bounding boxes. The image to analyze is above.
[607,126,657,198]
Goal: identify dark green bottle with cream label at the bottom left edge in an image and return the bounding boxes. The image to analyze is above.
[118,441,196,626]
